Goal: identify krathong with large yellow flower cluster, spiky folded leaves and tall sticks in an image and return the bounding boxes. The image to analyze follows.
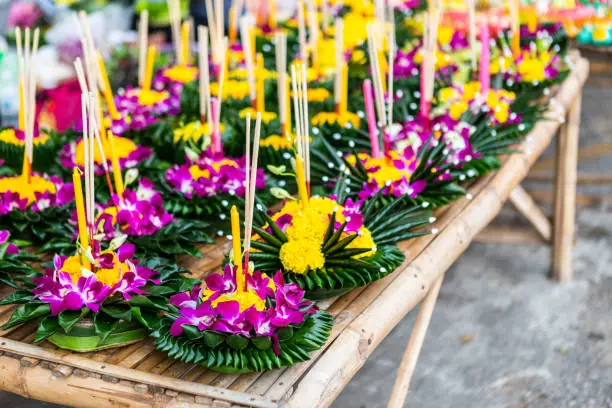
[250,69,431,299]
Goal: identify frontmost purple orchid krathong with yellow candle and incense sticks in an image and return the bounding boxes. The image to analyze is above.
[150,115,332,373]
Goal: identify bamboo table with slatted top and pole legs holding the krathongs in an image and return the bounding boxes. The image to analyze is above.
[0,56,588,408]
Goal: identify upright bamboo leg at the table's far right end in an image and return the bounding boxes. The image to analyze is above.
[552,93,582,282]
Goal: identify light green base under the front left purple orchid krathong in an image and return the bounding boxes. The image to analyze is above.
[47,319,148,353]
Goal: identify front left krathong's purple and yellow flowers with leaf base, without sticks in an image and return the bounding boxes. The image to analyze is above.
[0,240,191,352]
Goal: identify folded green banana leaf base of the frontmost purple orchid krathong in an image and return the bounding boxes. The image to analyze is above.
[152,310,333,374]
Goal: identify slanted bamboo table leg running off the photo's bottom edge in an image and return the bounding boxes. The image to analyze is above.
[387,275,444,408]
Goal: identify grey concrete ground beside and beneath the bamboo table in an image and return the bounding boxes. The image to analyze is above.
[0,88,612,408]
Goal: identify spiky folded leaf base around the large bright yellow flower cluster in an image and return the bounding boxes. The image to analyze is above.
[250,195,432,300]
